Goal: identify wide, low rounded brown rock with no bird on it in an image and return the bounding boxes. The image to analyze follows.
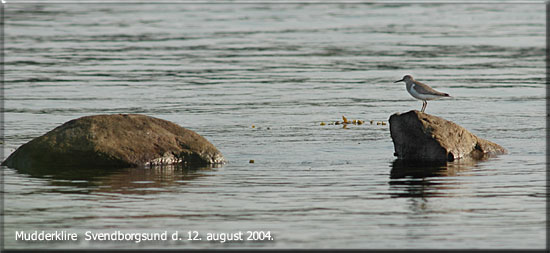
[2,114,225,169]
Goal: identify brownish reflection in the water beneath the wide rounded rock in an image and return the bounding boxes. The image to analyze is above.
[12,165,220,194]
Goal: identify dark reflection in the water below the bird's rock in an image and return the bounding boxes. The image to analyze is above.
[389,159,475,198]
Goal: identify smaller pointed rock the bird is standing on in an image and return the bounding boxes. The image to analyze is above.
[389,110,507,162]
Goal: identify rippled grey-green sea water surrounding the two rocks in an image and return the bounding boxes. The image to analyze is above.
[2,3,547,249]
